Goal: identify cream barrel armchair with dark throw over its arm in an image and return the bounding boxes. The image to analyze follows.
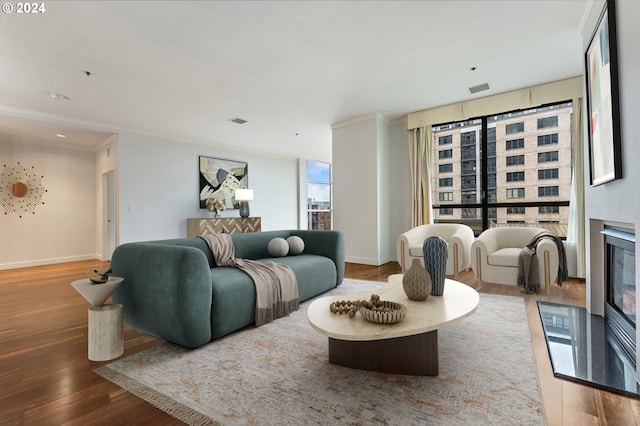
[471,227,560,294]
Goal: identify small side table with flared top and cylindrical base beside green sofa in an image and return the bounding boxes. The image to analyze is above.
[71,277,124,361]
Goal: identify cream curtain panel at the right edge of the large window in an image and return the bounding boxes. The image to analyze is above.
[567,98,586,278]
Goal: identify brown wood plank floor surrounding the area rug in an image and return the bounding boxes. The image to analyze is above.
[0,261,640,425]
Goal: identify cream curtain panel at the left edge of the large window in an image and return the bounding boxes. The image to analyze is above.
[408,126,431,228]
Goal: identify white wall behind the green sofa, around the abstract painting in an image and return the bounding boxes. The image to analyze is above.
[118,133,298,244]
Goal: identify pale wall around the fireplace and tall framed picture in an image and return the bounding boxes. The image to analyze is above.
[583,0,640,379]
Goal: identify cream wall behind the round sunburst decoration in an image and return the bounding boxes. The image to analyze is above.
[0,141,97,269]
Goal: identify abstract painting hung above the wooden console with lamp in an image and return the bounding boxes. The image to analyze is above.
[198,155,249,209]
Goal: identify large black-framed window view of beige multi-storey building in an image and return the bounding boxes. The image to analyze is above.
[431,102,573,238]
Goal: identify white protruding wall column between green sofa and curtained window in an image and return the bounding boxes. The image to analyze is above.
[332,114,411,265]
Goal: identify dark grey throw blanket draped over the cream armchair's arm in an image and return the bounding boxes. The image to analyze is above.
[518,231,567,294]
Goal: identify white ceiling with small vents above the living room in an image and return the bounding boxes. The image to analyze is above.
[0,0,593,160]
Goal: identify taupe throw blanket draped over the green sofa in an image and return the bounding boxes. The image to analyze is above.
[200,234,299,327]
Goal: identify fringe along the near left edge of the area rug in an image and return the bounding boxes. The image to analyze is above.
[93,366,220,426]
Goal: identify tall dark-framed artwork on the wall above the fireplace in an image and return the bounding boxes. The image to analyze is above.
[585,0,622,186]
